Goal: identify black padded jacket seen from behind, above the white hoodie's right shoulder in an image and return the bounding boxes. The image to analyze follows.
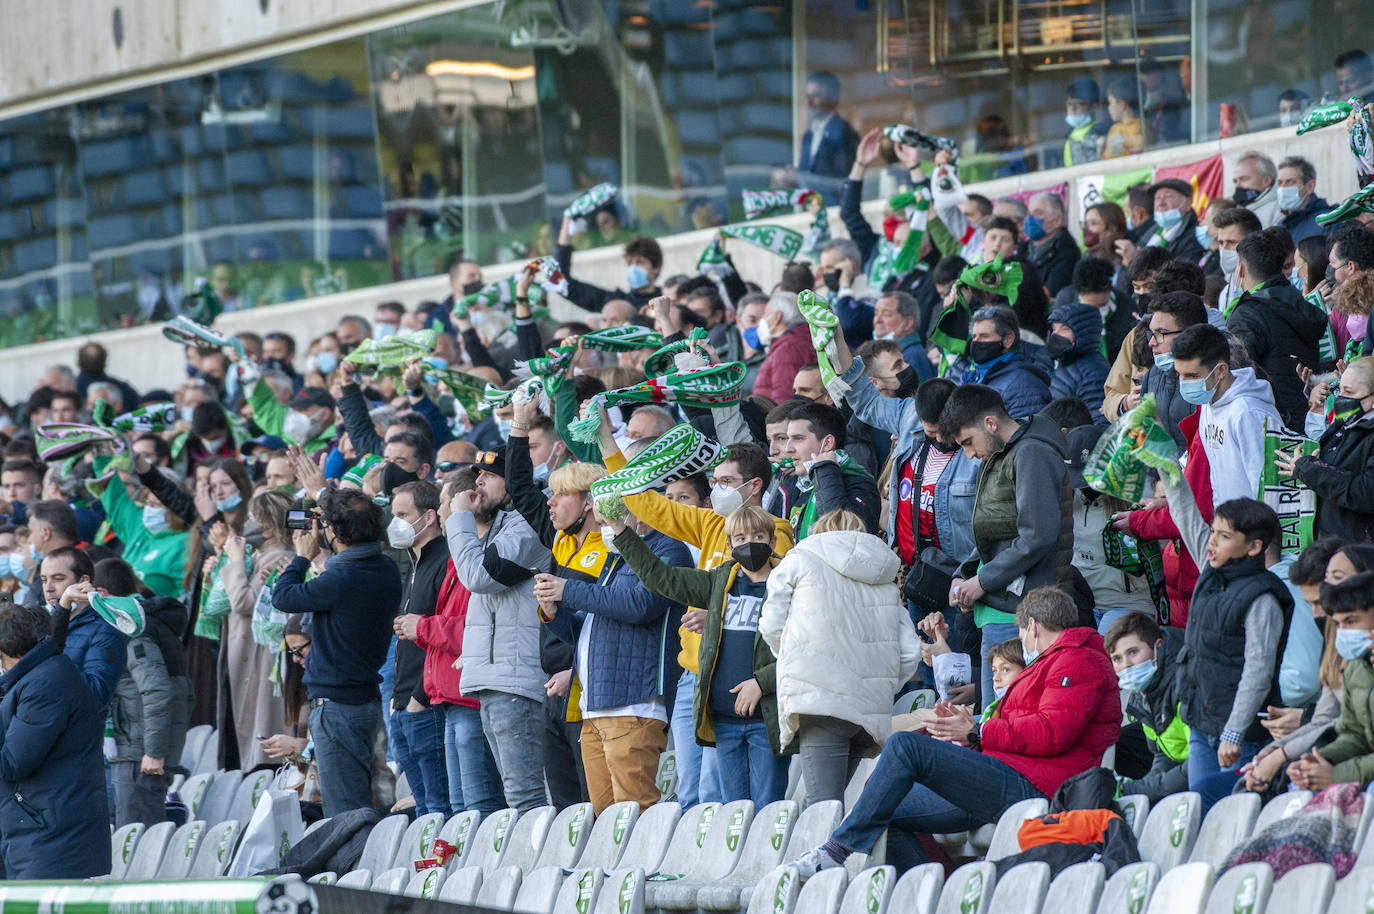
[1226,276,1327,429]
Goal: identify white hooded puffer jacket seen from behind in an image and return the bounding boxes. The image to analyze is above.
[758,531,921,748]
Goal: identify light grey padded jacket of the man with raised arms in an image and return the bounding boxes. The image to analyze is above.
[445,510,554,701]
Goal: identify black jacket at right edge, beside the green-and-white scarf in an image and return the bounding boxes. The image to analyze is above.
[1296,412,1374,543]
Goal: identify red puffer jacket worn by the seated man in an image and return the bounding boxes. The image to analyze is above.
[980,628,1121,797]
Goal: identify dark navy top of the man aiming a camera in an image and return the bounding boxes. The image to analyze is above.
[272,543,401,705]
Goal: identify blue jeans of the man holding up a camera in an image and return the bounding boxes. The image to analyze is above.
[311,701,382,816]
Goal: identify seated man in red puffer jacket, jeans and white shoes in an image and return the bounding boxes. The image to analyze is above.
[794,587,1121,880]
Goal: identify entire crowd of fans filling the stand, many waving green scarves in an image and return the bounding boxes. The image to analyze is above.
[0,58,1374,878]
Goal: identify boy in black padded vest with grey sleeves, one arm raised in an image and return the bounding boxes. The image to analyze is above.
[1164,464,1293,796]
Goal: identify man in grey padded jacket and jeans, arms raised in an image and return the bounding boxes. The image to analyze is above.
[445,452,552,812]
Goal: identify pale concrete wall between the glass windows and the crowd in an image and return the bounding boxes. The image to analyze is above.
[0,123,1356,401]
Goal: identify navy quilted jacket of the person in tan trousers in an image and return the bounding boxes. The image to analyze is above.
[548,531,695,711]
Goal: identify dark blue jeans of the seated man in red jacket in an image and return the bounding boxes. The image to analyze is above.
[834,733,1044,863]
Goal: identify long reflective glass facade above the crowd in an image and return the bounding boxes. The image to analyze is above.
[0,0,1363,345]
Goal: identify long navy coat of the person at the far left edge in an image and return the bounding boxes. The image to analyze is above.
[0,634,108,880]
